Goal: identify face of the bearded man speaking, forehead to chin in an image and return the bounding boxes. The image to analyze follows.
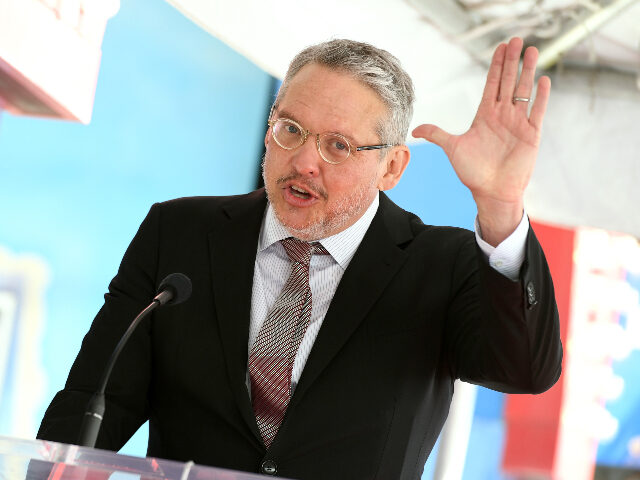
[263,64,386,240]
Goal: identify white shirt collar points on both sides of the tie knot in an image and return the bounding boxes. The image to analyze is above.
[258,195,380,269]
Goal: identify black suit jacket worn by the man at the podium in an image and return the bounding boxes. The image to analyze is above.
[38,190,562,480]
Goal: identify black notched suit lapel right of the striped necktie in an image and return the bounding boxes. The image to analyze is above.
[289,194,413,409]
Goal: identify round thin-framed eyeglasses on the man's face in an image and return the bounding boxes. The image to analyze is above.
[267,118,393,165]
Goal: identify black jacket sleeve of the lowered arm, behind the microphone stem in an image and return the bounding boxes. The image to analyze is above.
[37,205,160,450]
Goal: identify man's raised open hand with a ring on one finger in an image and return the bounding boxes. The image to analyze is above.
[413,38,551,245]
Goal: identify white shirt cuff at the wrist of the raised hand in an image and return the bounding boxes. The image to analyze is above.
[475,213,529,281]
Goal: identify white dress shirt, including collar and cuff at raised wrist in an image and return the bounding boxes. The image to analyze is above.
[247,195,529,393]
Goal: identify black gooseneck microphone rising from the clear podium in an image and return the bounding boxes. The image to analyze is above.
[78,273,191,448]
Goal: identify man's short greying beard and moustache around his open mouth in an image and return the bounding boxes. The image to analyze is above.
[262,155,377,242]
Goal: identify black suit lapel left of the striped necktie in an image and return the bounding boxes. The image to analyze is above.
[209,190,266,445]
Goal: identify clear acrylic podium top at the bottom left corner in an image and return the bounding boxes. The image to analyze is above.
[0,436,290,480]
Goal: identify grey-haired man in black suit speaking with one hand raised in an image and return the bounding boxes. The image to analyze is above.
[39,39,562,480]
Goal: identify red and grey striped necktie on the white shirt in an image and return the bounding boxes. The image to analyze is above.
[249,237,329,448]
